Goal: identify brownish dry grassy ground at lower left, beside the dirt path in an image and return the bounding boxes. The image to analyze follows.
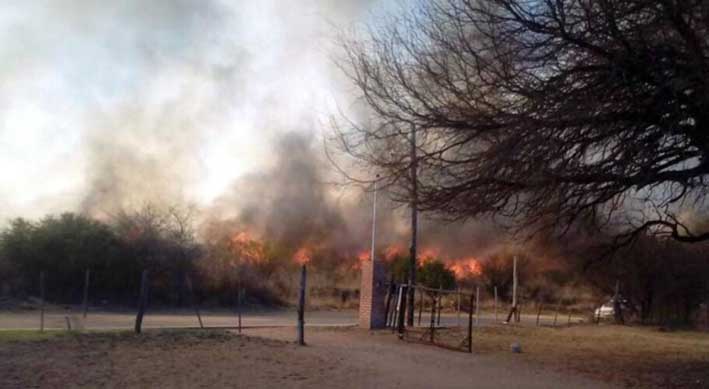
[0,330,336,388]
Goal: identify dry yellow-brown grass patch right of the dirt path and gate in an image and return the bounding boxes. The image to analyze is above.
[426,325,709,388]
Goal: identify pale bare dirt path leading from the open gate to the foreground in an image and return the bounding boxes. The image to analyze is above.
[247,329,612,389]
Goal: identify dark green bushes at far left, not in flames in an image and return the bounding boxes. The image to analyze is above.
[0,207,201,304]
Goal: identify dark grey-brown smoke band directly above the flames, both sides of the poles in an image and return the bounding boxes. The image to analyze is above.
[202,132,502,266]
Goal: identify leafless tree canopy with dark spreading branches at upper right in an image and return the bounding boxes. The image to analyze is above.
[337,0,709,242]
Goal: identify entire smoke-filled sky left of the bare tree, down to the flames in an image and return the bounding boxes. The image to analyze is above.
[0,0,508,266]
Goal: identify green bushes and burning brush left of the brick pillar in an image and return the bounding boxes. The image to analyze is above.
[0,207,351,306]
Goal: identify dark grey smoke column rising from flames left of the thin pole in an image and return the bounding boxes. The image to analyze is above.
[210,132,356,250]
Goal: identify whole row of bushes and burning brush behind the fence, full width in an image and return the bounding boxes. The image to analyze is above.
[0,206,709,324]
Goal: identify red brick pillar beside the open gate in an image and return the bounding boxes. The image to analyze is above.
[359,261,387,329]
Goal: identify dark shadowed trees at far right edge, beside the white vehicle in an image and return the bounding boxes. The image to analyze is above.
[576,236,709,326]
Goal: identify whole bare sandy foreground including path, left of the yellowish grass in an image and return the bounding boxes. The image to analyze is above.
[0,328,609,389]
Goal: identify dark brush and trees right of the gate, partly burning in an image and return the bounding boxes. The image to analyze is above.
[470,236,709,326]
